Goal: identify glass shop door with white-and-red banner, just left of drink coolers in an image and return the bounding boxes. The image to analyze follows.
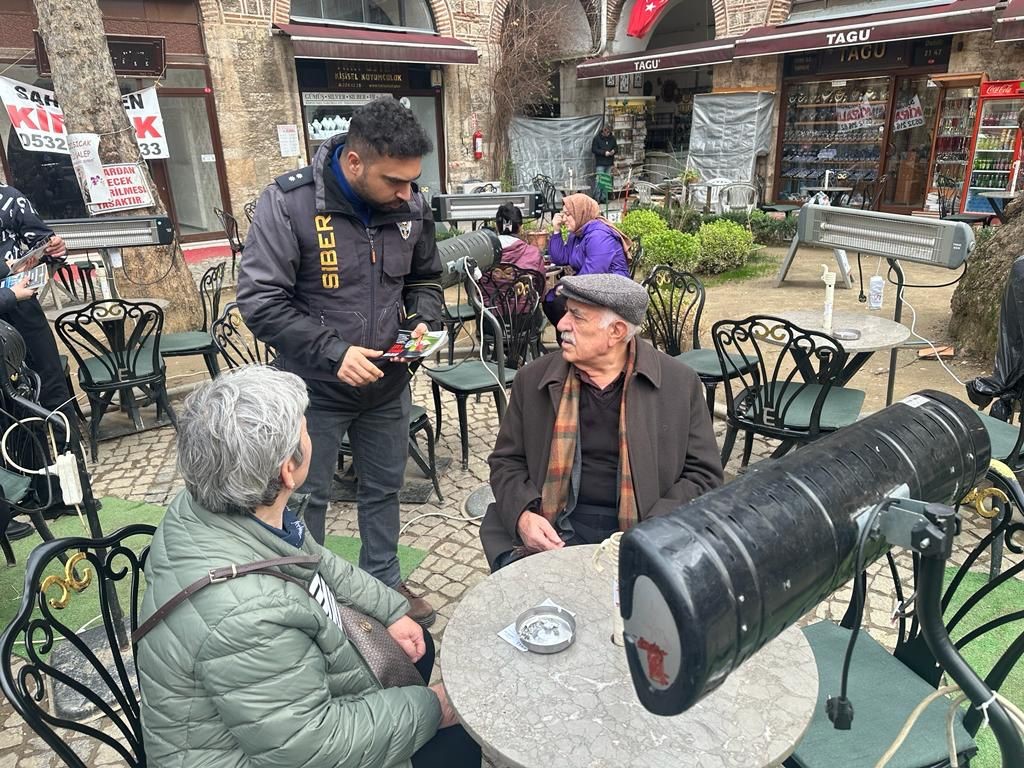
[882,76,939,209]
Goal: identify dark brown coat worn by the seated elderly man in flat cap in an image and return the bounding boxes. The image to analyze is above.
[480,340,722,568]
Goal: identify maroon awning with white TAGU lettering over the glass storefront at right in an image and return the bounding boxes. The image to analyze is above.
[735,0,996,58]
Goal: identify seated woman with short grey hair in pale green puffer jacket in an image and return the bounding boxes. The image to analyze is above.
[136,366,480,768]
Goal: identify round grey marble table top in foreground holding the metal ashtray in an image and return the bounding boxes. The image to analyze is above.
[441,546,818,768]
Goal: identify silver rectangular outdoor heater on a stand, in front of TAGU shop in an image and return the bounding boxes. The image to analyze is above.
[775,204,974,406]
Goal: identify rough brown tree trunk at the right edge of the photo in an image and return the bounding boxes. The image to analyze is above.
[949,199,1024,364]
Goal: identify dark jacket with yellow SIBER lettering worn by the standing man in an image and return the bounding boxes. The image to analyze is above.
[238,134,444,386]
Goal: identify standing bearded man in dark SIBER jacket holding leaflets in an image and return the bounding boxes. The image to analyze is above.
[238,96,443,626]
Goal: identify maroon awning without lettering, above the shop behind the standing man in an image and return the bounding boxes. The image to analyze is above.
[274,24,480,63]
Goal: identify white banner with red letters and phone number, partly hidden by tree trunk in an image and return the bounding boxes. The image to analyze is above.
[0,77,170,160]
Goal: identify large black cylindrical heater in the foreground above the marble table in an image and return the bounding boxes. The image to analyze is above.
[618,391,990,715]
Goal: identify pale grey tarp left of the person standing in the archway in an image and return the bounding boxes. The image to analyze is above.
[509,115,603,187]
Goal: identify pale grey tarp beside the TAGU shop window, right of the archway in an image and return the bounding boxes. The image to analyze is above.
[686,91,774,181]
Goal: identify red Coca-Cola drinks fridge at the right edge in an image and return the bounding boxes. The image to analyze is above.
[962,80,1024,213]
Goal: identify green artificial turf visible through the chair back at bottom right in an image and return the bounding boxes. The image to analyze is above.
[946,563,1024,768]
